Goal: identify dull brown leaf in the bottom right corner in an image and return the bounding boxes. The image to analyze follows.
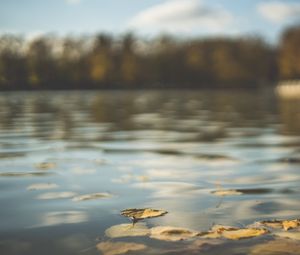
[250,238,300,255]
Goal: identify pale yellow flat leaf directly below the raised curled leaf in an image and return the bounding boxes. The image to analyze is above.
[105,223,150,238]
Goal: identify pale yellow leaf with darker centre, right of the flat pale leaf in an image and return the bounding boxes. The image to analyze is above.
[150,226,199,241]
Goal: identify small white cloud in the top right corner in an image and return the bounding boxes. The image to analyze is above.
[257,1,300,23]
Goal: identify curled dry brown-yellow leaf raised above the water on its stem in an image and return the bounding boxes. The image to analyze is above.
[121,208,168,221]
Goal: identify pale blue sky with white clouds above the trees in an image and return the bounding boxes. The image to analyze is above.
[0,0,300,42]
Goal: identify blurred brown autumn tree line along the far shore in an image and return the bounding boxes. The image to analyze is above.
[0,26,300,90]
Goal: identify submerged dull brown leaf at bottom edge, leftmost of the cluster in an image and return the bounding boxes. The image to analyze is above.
[96,242,147,255]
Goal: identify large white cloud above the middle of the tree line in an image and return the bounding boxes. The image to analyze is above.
[129,0,233,32]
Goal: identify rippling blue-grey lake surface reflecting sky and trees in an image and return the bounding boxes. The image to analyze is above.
[0,91,300,255]
